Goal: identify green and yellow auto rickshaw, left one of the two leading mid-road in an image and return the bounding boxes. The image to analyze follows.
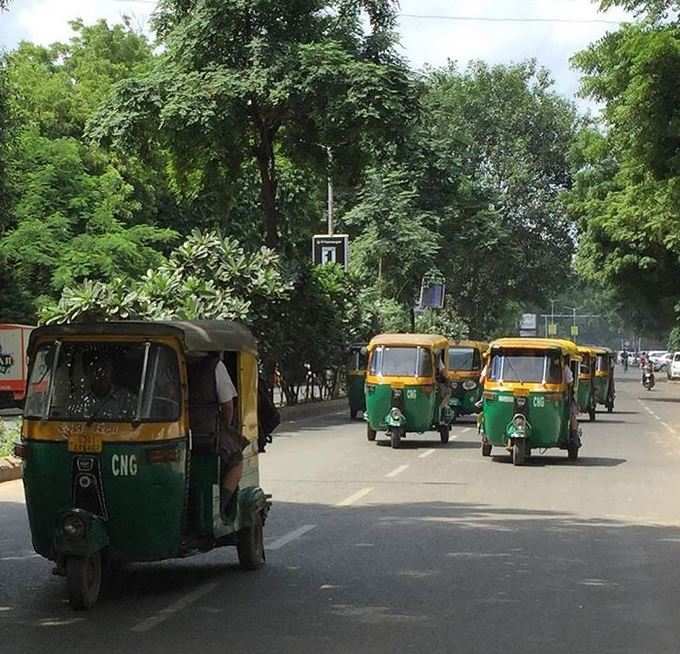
[364,334,451,448]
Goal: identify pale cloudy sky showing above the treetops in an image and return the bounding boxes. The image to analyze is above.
[0,0,631,111]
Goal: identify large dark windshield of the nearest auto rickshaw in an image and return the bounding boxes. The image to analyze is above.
[24,341,180,422]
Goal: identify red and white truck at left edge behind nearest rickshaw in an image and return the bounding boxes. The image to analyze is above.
[0,323,35,408]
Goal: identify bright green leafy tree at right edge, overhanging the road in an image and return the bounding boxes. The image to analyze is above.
[567,23,680,328]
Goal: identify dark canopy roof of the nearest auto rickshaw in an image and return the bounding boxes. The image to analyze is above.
[29,320,257,354]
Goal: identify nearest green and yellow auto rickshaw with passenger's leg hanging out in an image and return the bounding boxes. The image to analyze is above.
[15,321,270,609]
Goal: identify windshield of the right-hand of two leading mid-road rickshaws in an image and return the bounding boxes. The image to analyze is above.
[489,348,562,384]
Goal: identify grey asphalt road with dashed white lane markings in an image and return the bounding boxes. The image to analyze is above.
[0,370,680,654]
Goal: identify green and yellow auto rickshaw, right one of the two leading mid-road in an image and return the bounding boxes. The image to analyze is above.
[480,338,581,465]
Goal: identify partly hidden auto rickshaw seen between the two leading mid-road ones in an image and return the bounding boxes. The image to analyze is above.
[448,340,489,421]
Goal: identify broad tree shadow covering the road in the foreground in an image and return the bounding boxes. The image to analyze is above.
[0,500,680,654]
